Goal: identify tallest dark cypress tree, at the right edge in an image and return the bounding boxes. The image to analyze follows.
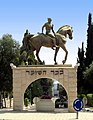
[84,13,93,93]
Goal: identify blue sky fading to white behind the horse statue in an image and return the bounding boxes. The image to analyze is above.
[0,0,93,65]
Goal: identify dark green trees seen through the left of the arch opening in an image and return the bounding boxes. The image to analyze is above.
[24,78,53,104]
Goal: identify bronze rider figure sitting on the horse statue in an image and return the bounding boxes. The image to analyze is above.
[42,18,56,49]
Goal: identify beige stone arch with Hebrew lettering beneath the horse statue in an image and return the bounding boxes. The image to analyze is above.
[12,65,77,112]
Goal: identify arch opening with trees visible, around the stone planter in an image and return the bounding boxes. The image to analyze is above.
[24,78,68,111]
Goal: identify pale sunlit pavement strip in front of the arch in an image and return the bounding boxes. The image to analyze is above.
[0,109,93,120]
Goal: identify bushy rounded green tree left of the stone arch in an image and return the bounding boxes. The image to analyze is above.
[0,34,20,106]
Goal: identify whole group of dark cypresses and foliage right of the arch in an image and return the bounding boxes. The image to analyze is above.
[77,13,93,94]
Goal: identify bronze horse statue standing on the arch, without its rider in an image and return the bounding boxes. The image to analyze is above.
[21,25,73,64]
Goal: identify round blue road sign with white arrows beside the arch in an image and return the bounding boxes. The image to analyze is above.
[73,99,84,111]
